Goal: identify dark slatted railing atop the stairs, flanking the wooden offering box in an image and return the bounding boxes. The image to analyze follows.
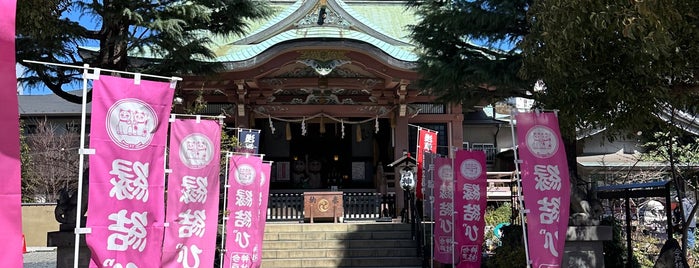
[267,192,396,221]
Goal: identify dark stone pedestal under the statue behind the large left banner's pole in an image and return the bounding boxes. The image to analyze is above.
[46,224,91,268]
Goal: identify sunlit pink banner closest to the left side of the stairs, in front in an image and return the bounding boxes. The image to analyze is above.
[223,154,262,267]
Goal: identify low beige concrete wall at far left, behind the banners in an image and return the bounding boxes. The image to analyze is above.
[22,204,58,247]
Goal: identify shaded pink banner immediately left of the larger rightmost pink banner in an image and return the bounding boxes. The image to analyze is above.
[454,150,488,268]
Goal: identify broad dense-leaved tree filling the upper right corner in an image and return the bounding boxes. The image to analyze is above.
[520,0,699,140]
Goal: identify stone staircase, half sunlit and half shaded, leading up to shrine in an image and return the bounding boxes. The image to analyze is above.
[262,223,421,268]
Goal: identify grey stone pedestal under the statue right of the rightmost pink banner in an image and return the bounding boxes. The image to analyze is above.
[561,225,612,268]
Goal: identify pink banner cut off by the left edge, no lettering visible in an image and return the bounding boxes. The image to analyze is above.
[0,0,22,267]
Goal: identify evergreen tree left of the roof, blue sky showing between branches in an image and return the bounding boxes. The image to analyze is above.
[17,0,272,103]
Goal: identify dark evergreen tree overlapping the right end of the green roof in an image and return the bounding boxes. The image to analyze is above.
[409,0,533,109]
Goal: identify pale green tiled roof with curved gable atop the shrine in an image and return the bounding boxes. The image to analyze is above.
[209,0,418,62]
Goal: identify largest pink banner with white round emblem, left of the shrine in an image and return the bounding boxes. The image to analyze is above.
[85,76,174,267]
